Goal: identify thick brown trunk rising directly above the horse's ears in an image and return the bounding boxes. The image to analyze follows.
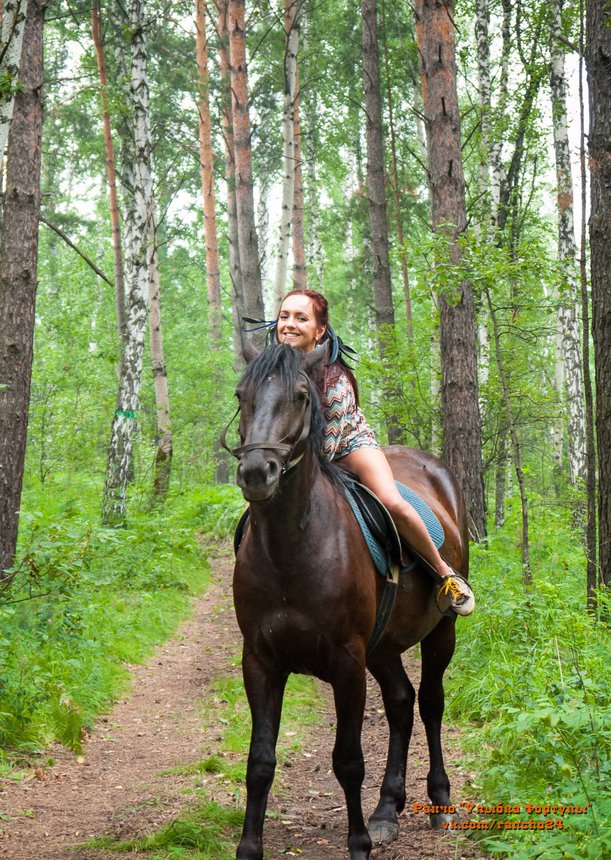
[227,0,264,344]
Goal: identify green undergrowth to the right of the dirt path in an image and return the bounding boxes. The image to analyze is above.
[447,501,611,860]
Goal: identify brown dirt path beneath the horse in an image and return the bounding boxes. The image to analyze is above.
[0,548,481,860]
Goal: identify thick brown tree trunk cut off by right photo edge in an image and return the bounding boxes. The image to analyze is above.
[586,0,611,585]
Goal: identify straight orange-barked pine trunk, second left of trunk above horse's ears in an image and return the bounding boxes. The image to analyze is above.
[195,0,221,350]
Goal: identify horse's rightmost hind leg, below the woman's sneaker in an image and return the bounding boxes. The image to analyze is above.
[418,618,456,829]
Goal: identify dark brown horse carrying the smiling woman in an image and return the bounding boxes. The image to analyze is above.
[227,345,468,860]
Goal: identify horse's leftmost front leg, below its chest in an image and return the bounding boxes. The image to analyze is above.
[236,646,287,860]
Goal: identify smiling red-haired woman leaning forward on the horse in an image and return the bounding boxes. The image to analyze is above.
[275,290,475,615]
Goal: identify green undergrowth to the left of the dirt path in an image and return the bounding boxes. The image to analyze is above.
[0,486,234,772]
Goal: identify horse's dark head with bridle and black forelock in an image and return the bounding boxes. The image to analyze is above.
[226,344,328,502]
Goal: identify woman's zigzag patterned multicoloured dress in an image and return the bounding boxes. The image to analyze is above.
[320,372,380,460]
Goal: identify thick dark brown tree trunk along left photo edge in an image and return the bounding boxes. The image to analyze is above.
[0,0,46,578]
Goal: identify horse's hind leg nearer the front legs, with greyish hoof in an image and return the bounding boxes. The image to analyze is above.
[369,657,416,843]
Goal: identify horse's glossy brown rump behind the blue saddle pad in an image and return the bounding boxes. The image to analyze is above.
[383,445,469,573]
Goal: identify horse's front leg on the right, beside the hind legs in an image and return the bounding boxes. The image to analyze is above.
[332,651,371,860]
